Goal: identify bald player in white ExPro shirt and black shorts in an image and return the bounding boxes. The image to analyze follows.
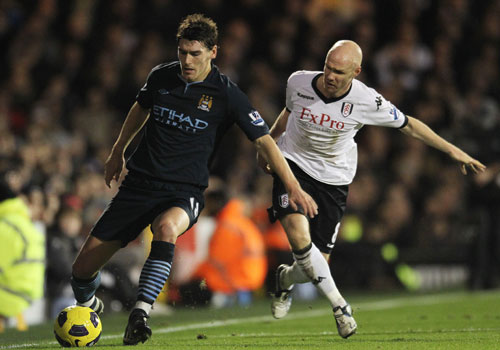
[259,40,486,338]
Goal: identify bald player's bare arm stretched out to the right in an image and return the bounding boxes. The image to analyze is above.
[401,116,486,175]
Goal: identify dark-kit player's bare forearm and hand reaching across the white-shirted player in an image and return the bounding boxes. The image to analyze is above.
[254,135,318,218]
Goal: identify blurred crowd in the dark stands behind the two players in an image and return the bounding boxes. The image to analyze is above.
[0,0,500,328]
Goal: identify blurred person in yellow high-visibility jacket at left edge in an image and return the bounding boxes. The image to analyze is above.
[0,178,45,332]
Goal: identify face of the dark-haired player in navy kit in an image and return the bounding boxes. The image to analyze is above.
[177,39,217,82]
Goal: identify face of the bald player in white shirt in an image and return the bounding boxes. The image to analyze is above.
[322,54,361,98]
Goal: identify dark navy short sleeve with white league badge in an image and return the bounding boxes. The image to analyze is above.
[227,84,269,141]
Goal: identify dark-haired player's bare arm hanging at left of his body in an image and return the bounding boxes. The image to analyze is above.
[104,102,149,187]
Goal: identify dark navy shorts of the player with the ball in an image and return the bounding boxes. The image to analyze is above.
[90,174,204,247]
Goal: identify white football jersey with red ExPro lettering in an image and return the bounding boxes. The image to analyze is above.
[278,71,407,185]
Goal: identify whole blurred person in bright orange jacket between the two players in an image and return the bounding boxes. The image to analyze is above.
[195,188,267,308]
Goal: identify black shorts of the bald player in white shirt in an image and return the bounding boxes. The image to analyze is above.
[268,160,348,254]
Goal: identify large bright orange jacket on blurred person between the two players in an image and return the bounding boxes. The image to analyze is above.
[195,199,267,294]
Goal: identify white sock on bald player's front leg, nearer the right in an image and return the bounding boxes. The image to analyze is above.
[293,244,346,307]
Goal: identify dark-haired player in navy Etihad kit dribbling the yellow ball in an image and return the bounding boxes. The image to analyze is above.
[71,14,317,345]
